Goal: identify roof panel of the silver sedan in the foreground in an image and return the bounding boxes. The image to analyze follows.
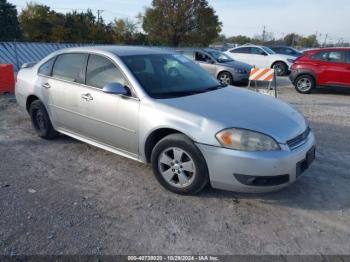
[54,45,174,56]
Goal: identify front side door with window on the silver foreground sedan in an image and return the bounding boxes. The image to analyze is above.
[81,54,140,157]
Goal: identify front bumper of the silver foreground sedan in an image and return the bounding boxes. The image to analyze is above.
[196,132,315,193]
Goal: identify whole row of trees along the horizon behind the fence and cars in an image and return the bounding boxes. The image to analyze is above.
[0,0,349,47]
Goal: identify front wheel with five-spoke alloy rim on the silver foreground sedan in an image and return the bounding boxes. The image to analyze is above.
[151,134,209,195]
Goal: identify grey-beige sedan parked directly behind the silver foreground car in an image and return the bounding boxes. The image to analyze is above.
[177,48,252,85]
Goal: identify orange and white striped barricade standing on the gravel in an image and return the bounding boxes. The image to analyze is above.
[248,68,277,97]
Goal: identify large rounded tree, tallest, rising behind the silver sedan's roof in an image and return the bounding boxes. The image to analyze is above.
[142,0,222,46]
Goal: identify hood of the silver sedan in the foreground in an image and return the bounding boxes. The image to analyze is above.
[158,86,307,143]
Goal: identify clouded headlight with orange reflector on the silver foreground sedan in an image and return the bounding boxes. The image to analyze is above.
[216,128,281,151]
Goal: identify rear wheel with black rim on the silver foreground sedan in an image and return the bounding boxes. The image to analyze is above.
[29,100,58,139]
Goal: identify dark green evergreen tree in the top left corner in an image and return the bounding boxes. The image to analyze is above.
[0,0,20,41]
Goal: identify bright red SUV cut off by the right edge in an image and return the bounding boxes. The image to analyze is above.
[289,48,350,94]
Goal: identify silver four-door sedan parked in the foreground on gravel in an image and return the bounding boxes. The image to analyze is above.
[16,46,315,194]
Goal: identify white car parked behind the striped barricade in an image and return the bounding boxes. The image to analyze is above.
[225,45,295,76]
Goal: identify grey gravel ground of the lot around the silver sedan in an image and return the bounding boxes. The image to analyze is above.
[0,79,350,255]
